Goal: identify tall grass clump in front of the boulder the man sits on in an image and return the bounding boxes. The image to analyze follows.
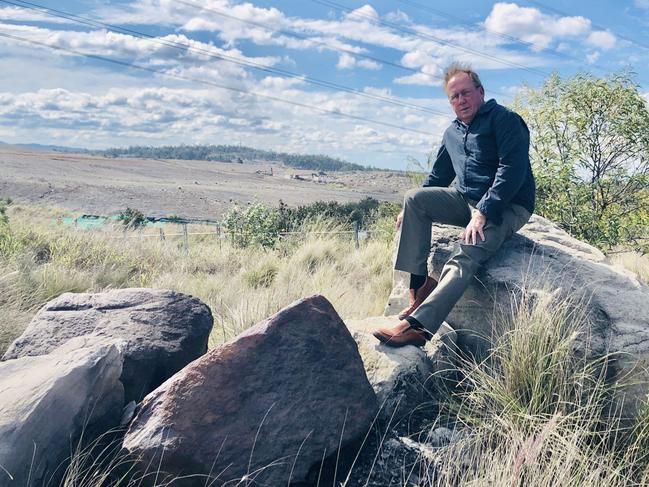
[410,291,649,487]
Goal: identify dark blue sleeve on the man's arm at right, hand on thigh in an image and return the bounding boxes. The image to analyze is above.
[476,110,530,225]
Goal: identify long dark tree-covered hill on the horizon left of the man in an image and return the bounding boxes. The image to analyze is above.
[97,145,372,171]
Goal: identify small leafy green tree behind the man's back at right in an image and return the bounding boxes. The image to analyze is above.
[515,73,649,249]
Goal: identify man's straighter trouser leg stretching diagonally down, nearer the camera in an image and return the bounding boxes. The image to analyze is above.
[410,205,531,334]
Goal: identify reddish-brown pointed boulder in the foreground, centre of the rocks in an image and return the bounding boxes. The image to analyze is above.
[123,296,378,485]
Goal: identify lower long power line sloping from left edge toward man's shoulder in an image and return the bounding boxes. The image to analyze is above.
[0,32,440,136]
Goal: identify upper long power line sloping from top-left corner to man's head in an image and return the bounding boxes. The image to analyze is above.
[0,0,447,116]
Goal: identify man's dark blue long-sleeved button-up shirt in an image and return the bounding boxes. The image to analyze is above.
[424,100,536,224]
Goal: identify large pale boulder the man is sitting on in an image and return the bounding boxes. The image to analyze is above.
[386,215,649,410]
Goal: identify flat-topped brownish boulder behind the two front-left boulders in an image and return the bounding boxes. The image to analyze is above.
[2,289,213,402]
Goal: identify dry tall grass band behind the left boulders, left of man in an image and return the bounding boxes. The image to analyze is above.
[0,206,391,351]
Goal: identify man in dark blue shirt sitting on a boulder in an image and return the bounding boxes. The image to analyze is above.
[374,64,535,347]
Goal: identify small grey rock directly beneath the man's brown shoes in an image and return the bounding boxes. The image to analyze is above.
[346,316,456,421]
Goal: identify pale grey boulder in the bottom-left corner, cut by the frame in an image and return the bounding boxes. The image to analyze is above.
[0,339,124,487]
